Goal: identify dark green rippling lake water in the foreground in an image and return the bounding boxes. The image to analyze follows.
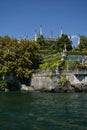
[0,92,87,130]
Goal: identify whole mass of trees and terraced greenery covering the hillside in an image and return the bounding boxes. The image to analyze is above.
[0,34,87,90]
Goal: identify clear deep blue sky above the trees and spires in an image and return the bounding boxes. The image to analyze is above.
[0,0,87,45]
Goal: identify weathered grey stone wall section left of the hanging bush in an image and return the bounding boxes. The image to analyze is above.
[31,71,59,90]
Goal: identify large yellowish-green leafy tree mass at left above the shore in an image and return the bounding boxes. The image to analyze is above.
[0,36,41,79]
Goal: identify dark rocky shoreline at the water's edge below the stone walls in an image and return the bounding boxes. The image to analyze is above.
[21,83,87,93]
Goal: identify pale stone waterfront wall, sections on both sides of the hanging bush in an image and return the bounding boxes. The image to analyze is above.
[31,71,87,90]
